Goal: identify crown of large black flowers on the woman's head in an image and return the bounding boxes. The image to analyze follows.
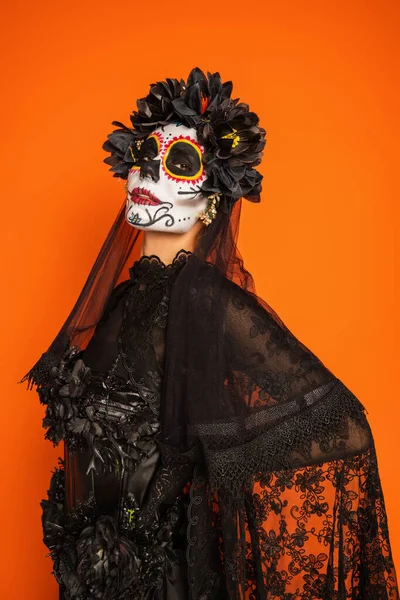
[103,67,266,207]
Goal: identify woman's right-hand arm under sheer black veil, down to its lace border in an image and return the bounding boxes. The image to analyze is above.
[200,283,372,485]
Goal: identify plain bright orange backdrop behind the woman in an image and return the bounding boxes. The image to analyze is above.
[0,0,400,600]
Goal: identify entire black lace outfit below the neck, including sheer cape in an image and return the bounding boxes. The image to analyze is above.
[38,246,399,600]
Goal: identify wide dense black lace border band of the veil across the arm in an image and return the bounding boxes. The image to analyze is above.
[203,380,373,499]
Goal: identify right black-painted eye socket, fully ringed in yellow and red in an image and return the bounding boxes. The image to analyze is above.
[163,139,203,181]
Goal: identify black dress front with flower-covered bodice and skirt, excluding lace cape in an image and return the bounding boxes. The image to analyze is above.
[42,251,194,600]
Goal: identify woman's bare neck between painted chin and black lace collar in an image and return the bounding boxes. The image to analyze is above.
[141,220,205,265]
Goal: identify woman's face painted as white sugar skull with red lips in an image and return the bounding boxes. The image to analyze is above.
[125,124,208,233]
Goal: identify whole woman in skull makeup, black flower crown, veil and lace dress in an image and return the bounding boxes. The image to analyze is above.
[26,68,398,600]
